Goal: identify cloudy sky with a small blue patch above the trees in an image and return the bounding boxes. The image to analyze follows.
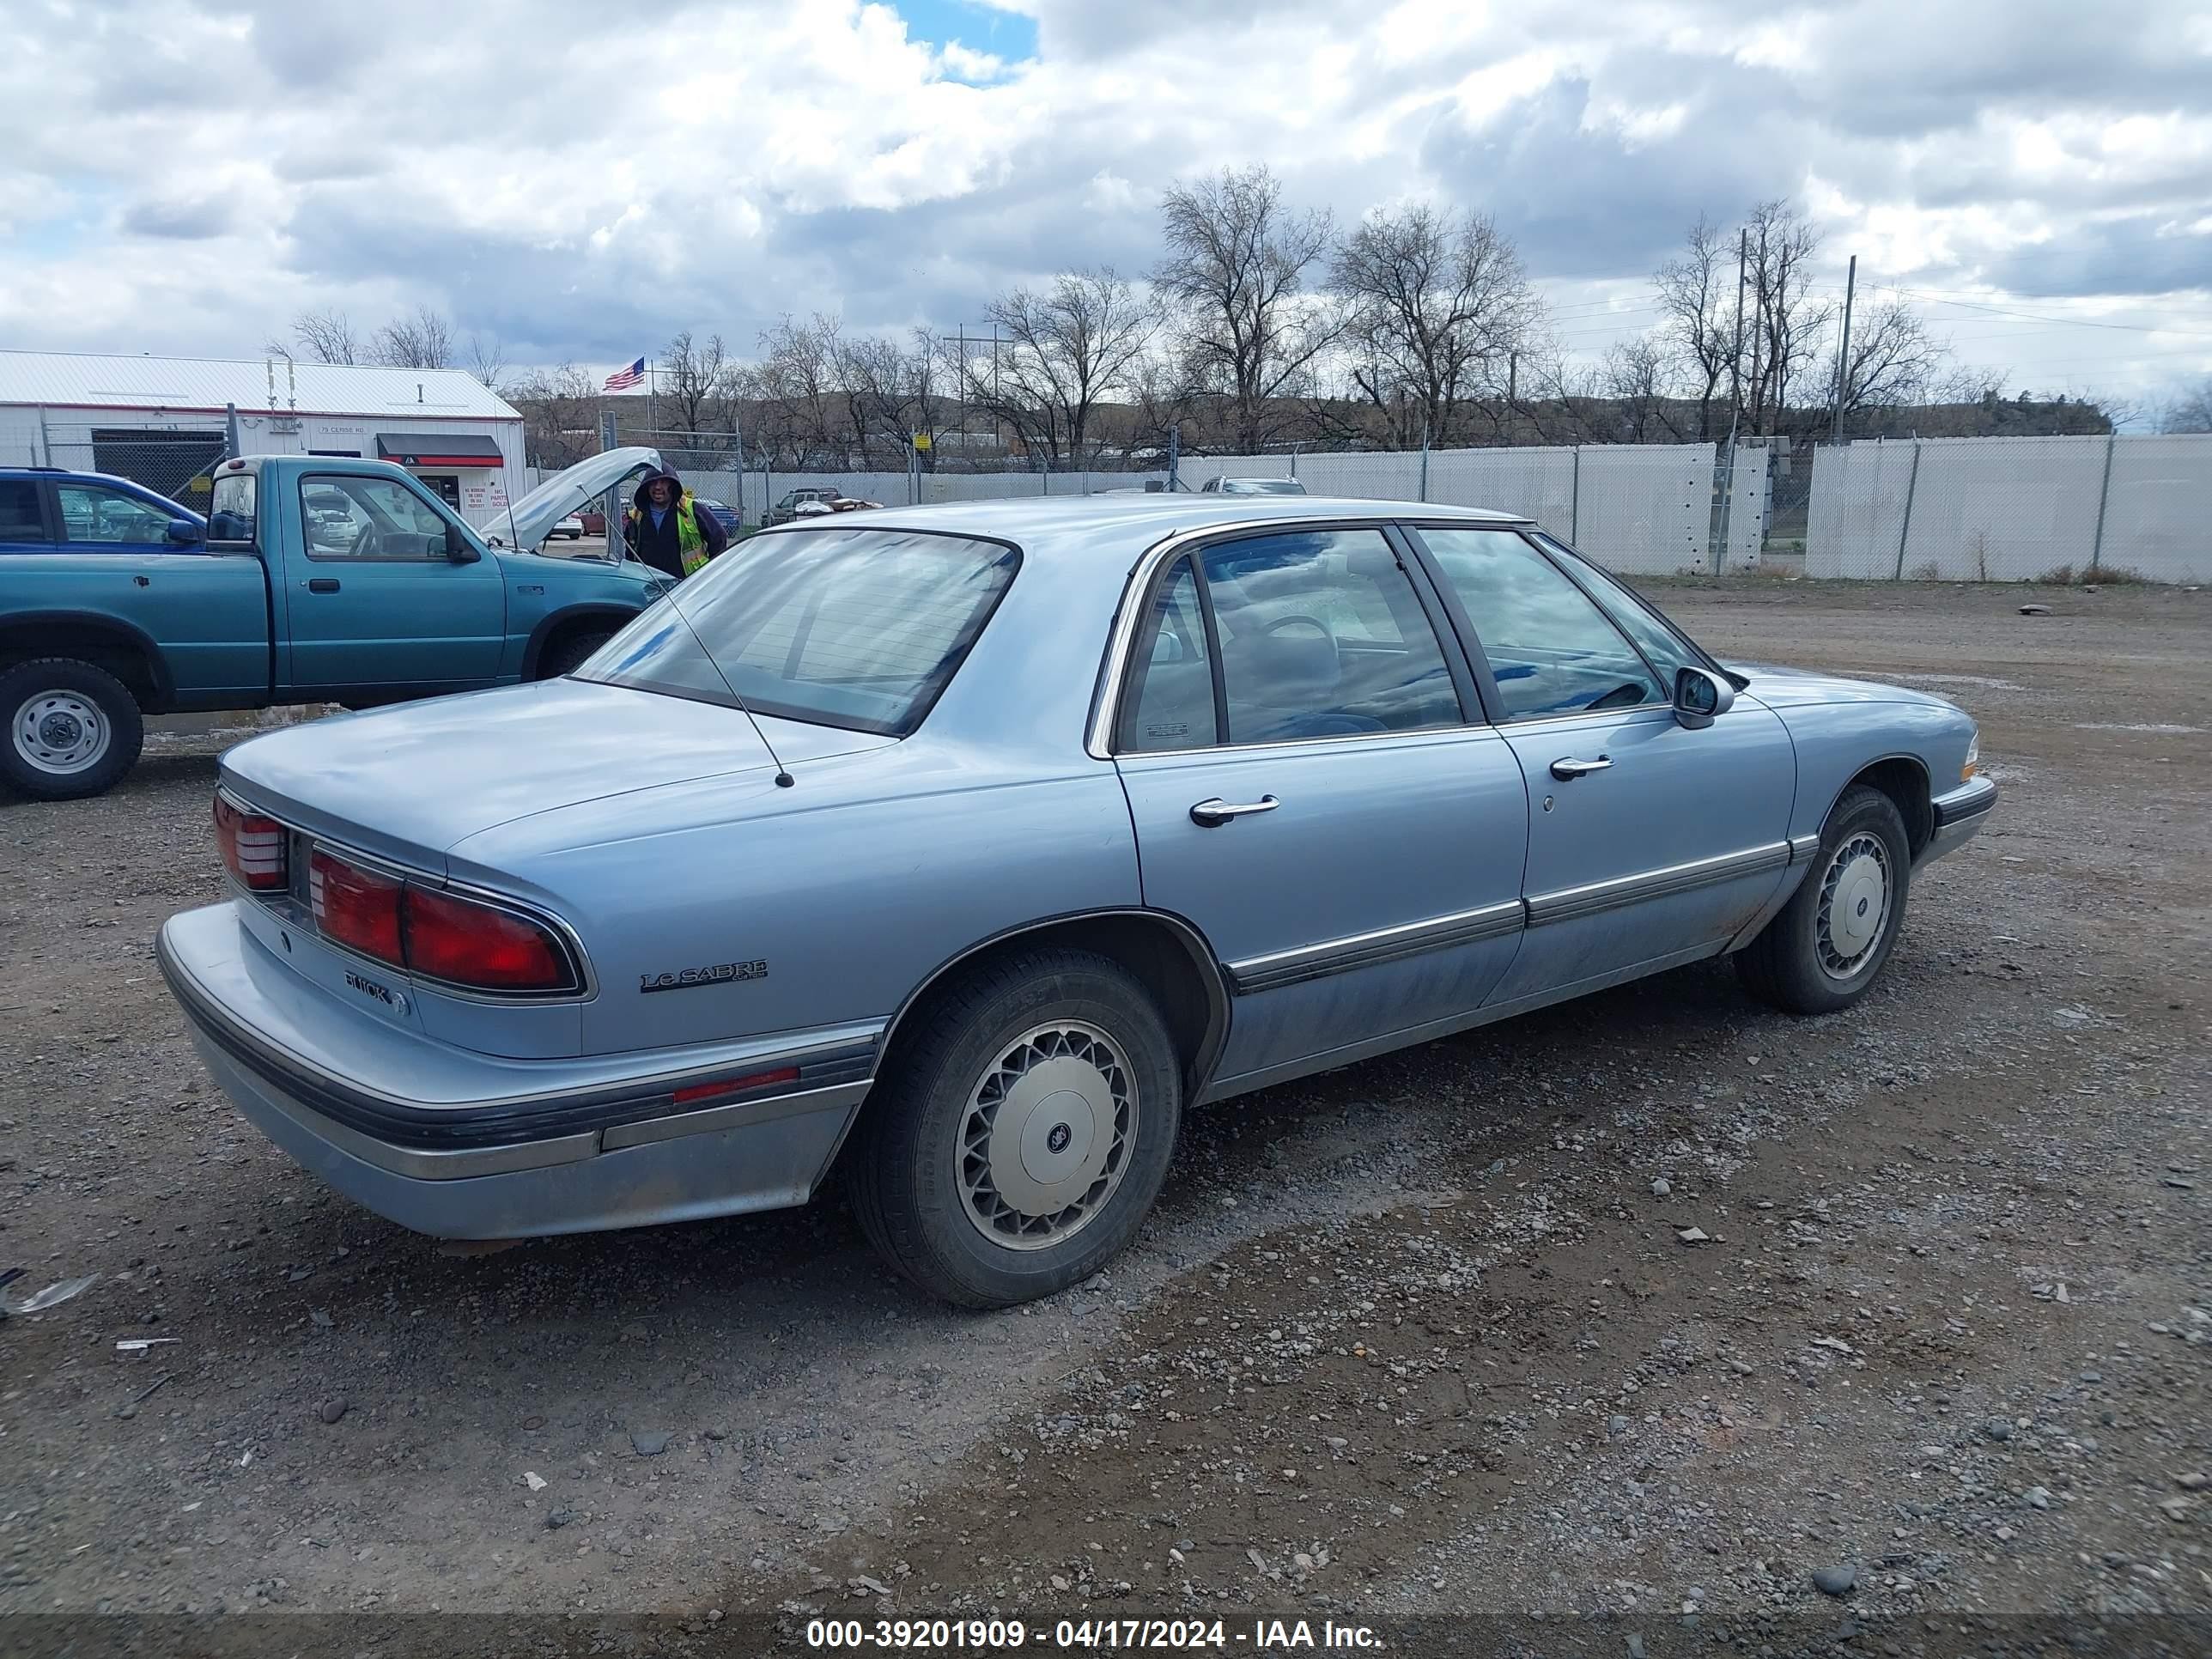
[0,0,2212,409]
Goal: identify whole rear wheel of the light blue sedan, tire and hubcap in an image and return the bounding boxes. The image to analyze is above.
[849,949,1182,1307]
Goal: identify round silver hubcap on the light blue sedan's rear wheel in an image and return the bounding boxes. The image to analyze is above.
[953,1020,1137,1249]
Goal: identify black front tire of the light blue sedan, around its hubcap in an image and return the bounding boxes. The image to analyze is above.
[1736,783,1913,1013]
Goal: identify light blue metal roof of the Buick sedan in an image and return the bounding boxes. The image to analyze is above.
[763,491,1535,557]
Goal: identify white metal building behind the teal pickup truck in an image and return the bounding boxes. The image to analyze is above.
[0,352,526,525]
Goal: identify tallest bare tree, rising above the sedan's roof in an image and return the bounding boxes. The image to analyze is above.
[1152,166,1336,452]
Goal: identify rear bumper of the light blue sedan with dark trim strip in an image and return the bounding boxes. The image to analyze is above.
[157,905,880,1239]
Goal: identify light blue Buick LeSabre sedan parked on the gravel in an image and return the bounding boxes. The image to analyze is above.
[159,495,1997,1307]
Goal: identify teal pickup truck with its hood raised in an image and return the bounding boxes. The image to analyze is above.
[0,449,672,801]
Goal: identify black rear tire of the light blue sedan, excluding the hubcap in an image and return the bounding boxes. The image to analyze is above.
[848,949,1183,1307]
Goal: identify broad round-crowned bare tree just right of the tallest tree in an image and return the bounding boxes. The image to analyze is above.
[1329,204,1541,449]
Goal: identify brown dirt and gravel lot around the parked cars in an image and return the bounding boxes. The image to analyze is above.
[0,581,2212,1655]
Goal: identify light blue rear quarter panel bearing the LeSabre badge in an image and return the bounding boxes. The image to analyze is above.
[447,734,1141,1053]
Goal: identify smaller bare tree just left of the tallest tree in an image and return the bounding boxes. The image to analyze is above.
[963,265,1159,465]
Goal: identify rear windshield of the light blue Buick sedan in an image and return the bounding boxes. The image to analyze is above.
[575,529,1020,737]
